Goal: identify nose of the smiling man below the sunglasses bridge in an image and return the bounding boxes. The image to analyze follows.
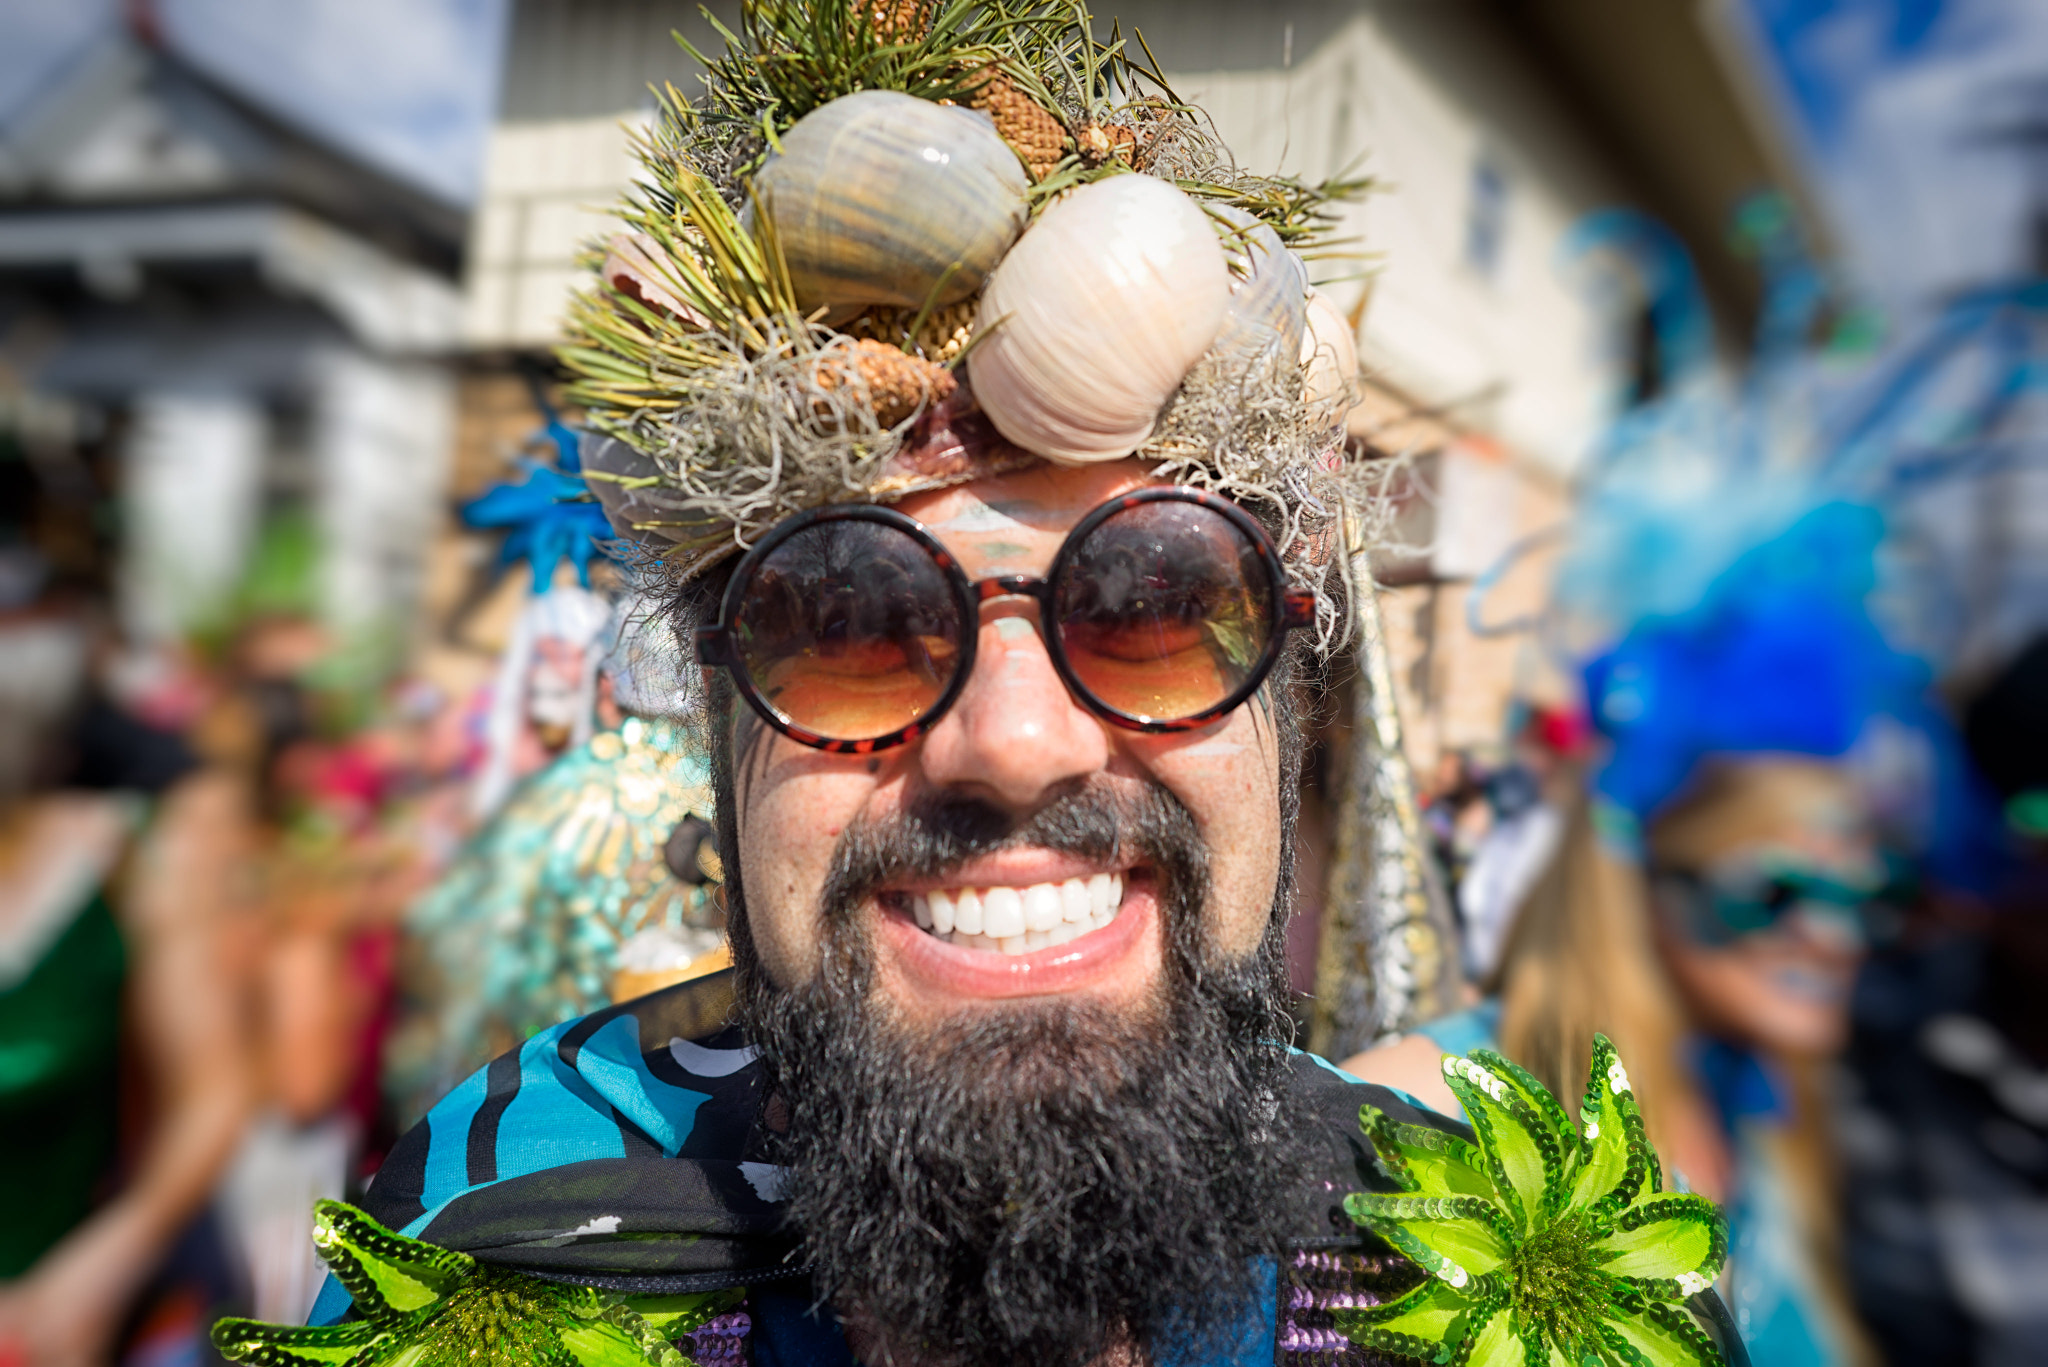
[918,603,1110,812]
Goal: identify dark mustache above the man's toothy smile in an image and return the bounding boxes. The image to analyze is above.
[823,779,1208,918]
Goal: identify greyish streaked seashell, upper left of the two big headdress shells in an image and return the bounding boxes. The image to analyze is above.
[754,90,1030,309]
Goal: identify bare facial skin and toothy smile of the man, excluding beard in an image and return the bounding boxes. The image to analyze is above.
[733,461,1282,1027]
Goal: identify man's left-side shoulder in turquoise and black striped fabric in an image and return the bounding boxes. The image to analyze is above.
[362,974,782,1289]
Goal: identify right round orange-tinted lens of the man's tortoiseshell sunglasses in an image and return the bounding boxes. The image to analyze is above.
[1053,500,1274,721]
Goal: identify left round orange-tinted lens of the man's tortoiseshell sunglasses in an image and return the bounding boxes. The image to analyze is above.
[733,521,961,740]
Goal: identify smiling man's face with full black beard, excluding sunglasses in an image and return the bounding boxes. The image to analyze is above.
[715,461,1305,1367]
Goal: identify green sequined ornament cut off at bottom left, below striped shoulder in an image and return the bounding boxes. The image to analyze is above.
[213,1201,739,1367]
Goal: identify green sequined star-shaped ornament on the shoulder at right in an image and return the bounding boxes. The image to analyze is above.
[1339,1035,1726,1367]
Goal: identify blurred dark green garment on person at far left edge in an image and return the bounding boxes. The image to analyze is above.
[0,892,127,1279]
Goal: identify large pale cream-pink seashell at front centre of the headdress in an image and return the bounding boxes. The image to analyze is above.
[969,174,1231,465]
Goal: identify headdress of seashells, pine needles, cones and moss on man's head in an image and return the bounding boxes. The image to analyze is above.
[559,0,1364,635]
